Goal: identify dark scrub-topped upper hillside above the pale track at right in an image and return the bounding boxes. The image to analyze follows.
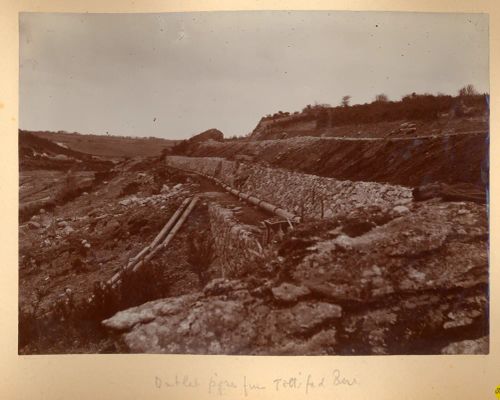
[250,94,487,140]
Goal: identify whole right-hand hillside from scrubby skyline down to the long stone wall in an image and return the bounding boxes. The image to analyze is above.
[172,93,489,187]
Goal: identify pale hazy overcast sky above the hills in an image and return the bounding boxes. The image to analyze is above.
[20,11,489,139]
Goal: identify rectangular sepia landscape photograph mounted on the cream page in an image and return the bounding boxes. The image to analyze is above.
[18,11,493,354]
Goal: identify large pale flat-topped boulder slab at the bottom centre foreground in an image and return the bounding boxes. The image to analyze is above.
[102,280,342,354]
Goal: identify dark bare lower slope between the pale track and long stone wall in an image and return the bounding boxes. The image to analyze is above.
[173,131,489,187]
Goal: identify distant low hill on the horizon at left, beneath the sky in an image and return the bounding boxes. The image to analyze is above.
[26,131,177,158]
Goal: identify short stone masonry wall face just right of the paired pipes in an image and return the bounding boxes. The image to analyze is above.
[208,203,263,278]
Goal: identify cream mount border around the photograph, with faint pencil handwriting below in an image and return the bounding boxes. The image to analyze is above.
[0,0,500,399]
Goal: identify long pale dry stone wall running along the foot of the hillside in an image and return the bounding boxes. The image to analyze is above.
[167,156,412,220]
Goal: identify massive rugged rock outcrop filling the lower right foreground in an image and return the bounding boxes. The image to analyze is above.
[103,200,489,355]
